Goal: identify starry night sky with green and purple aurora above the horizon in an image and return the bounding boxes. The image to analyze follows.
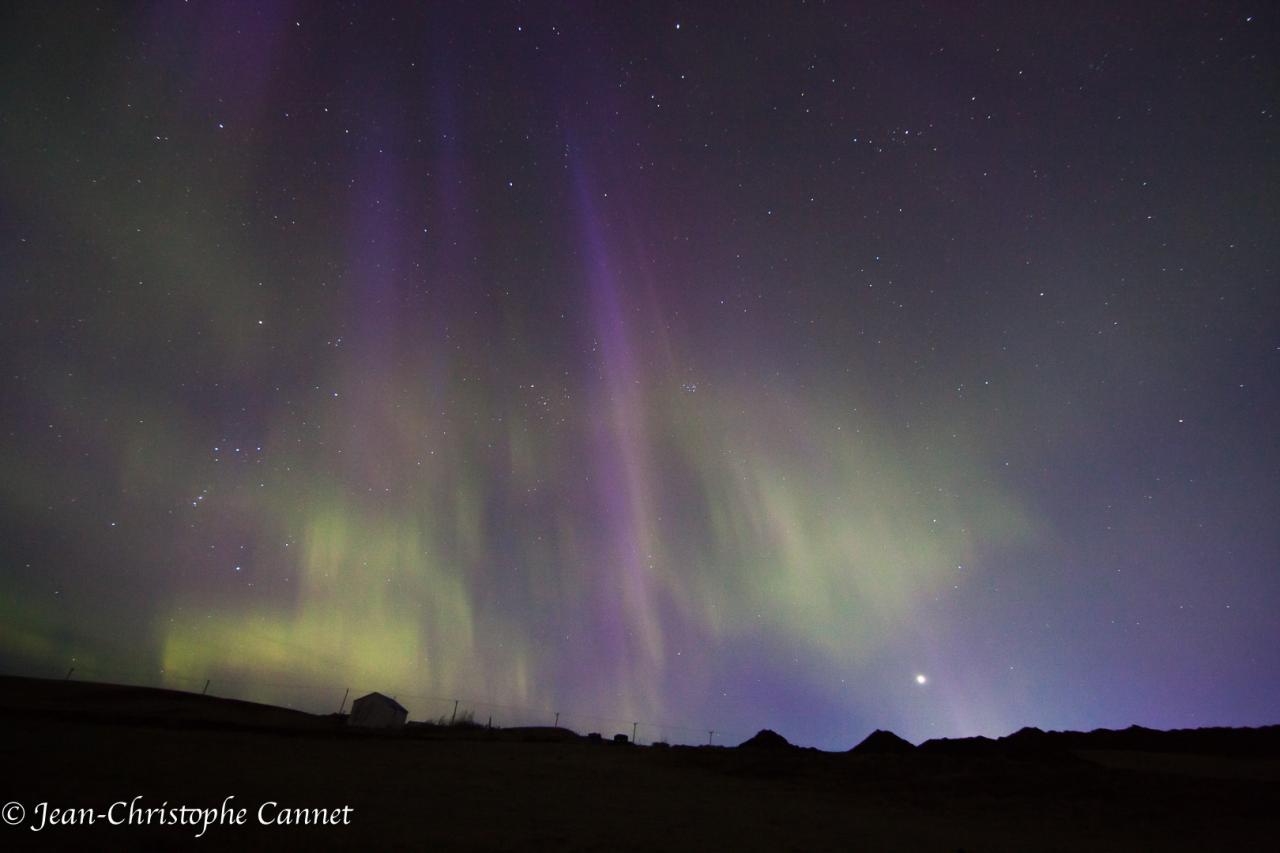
[0,1,1280,748]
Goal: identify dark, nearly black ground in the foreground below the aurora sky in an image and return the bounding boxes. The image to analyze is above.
[0,678,1280,850]
